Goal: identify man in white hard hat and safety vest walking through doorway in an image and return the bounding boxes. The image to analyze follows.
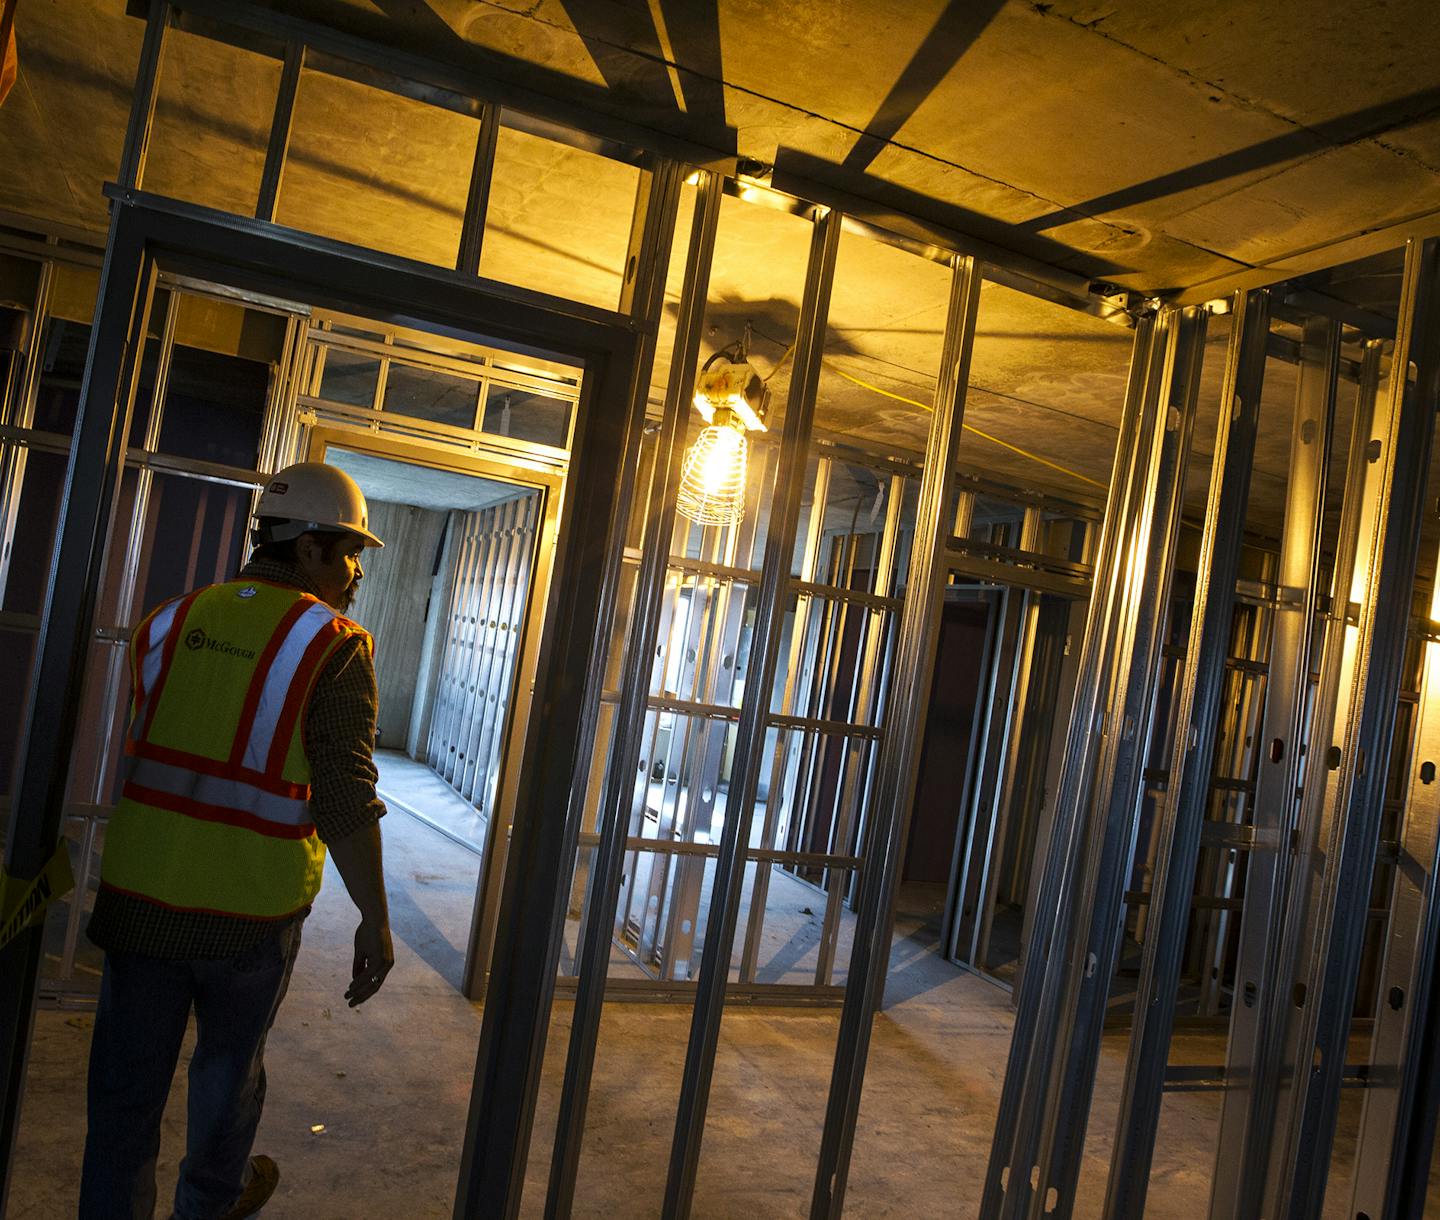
[79,462,395,1220]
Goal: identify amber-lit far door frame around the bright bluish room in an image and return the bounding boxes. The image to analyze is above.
[304,426,569,1000]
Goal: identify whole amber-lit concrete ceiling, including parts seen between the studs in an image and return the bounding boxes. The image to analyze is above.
[0,0,1440,523]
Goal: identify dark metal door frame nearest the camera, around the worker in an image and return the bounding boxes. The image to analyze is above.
[0,187,645,1210]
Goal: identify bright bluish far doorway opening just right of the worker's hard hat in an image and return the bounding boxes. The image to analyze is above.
[323,444,544,991]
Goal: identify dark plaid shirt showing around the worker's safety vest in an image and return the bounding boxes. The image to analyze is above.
[86,560,384,958]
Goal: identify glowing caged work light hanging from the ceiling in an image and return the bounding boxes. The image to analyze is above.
[675,327,769,526]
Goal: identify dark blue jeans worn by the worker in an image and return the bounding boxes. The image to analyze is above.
[79,919,302,1220]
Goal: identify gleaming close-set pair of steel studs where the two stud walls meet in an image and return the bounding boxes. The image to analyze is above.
[981,301,1204,1217]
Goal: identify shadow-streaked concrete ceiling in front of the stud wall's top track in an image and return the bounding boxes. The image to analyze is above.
[210,0,1440,291]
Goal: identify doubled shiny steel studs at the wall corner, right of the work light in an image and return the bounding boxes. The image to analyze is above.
[981,302,1204,1217]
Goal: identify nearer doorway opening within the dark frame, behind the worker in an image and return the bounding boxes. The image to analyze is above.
[0,277,580,1005]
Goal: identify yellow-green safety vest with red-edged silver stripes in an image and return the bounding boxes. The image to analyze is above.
[101,579,373,919]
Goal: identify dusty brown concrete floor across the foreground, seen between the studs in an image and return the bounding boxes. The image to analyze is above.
[9,815,1440,1220]
